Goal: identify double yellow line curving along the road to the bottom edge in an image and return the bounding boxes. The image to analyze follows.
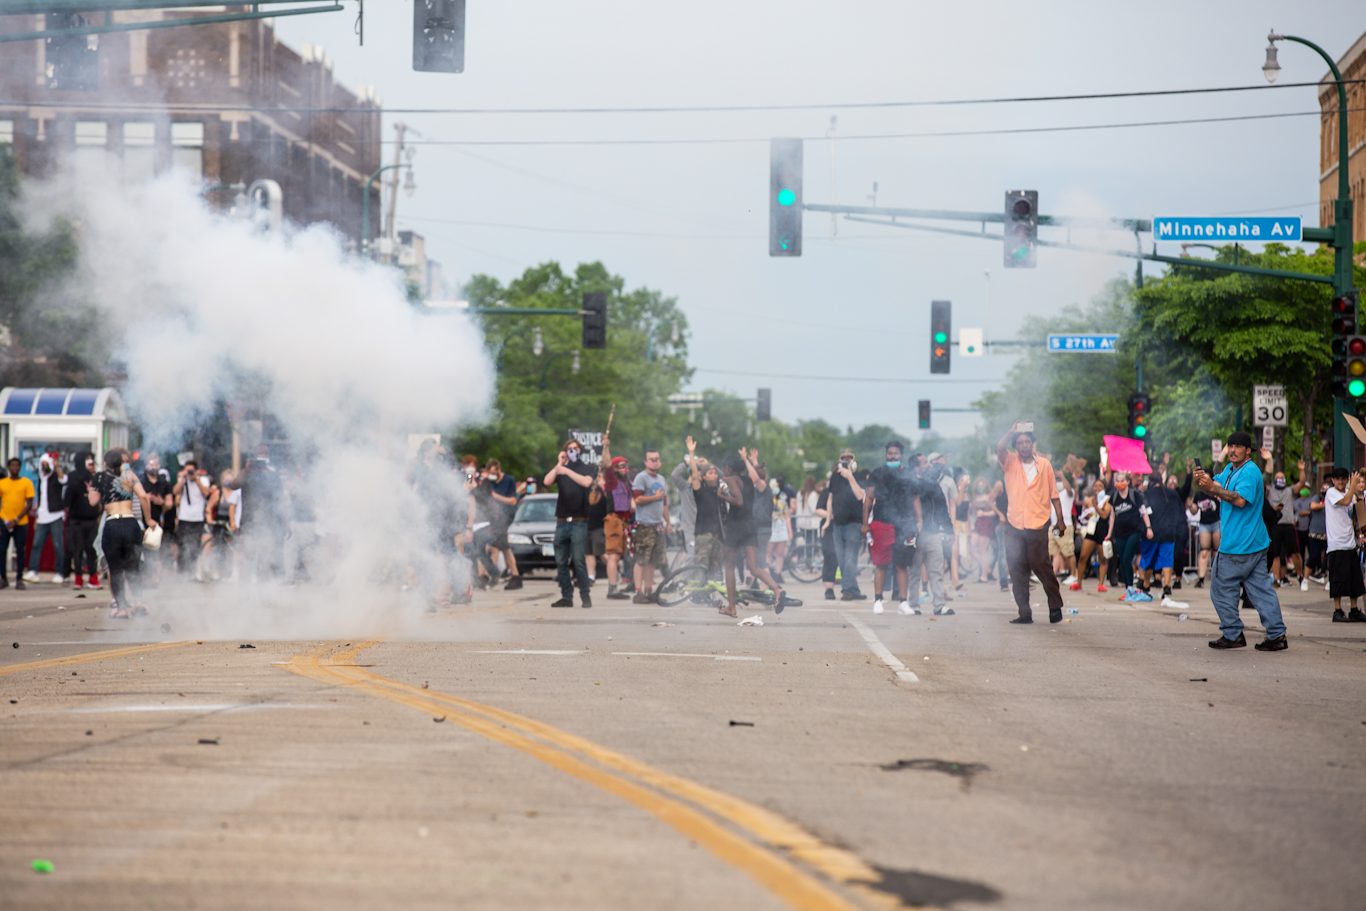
[280,642,928,911]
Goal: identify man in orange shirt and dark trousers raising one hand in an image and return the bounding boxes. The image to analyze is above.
[996,421,1067,623]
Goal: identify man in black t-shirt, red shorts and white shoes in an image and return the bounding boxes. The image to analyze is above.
[863,440,921,615]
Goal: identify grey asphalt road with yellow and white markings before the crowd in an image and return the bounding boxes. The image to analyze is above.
[0,565,1366,911]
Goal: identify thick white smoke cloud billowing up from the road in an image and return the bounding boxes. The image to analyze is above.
[29,167,493,638]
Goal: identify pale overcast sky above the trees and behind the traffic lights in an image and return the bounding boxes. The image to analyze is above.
[277,0,1366,436]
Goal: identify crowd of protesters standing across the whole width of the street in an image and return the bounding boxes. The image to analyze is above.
[0,422,1366,647]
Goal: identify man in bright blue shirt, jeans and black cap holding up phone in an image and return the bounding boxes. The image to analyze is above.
[1195,430,1288,651]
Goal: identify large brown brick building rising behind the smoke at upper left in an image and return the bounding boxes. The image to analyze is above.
[0,7,381,240]
